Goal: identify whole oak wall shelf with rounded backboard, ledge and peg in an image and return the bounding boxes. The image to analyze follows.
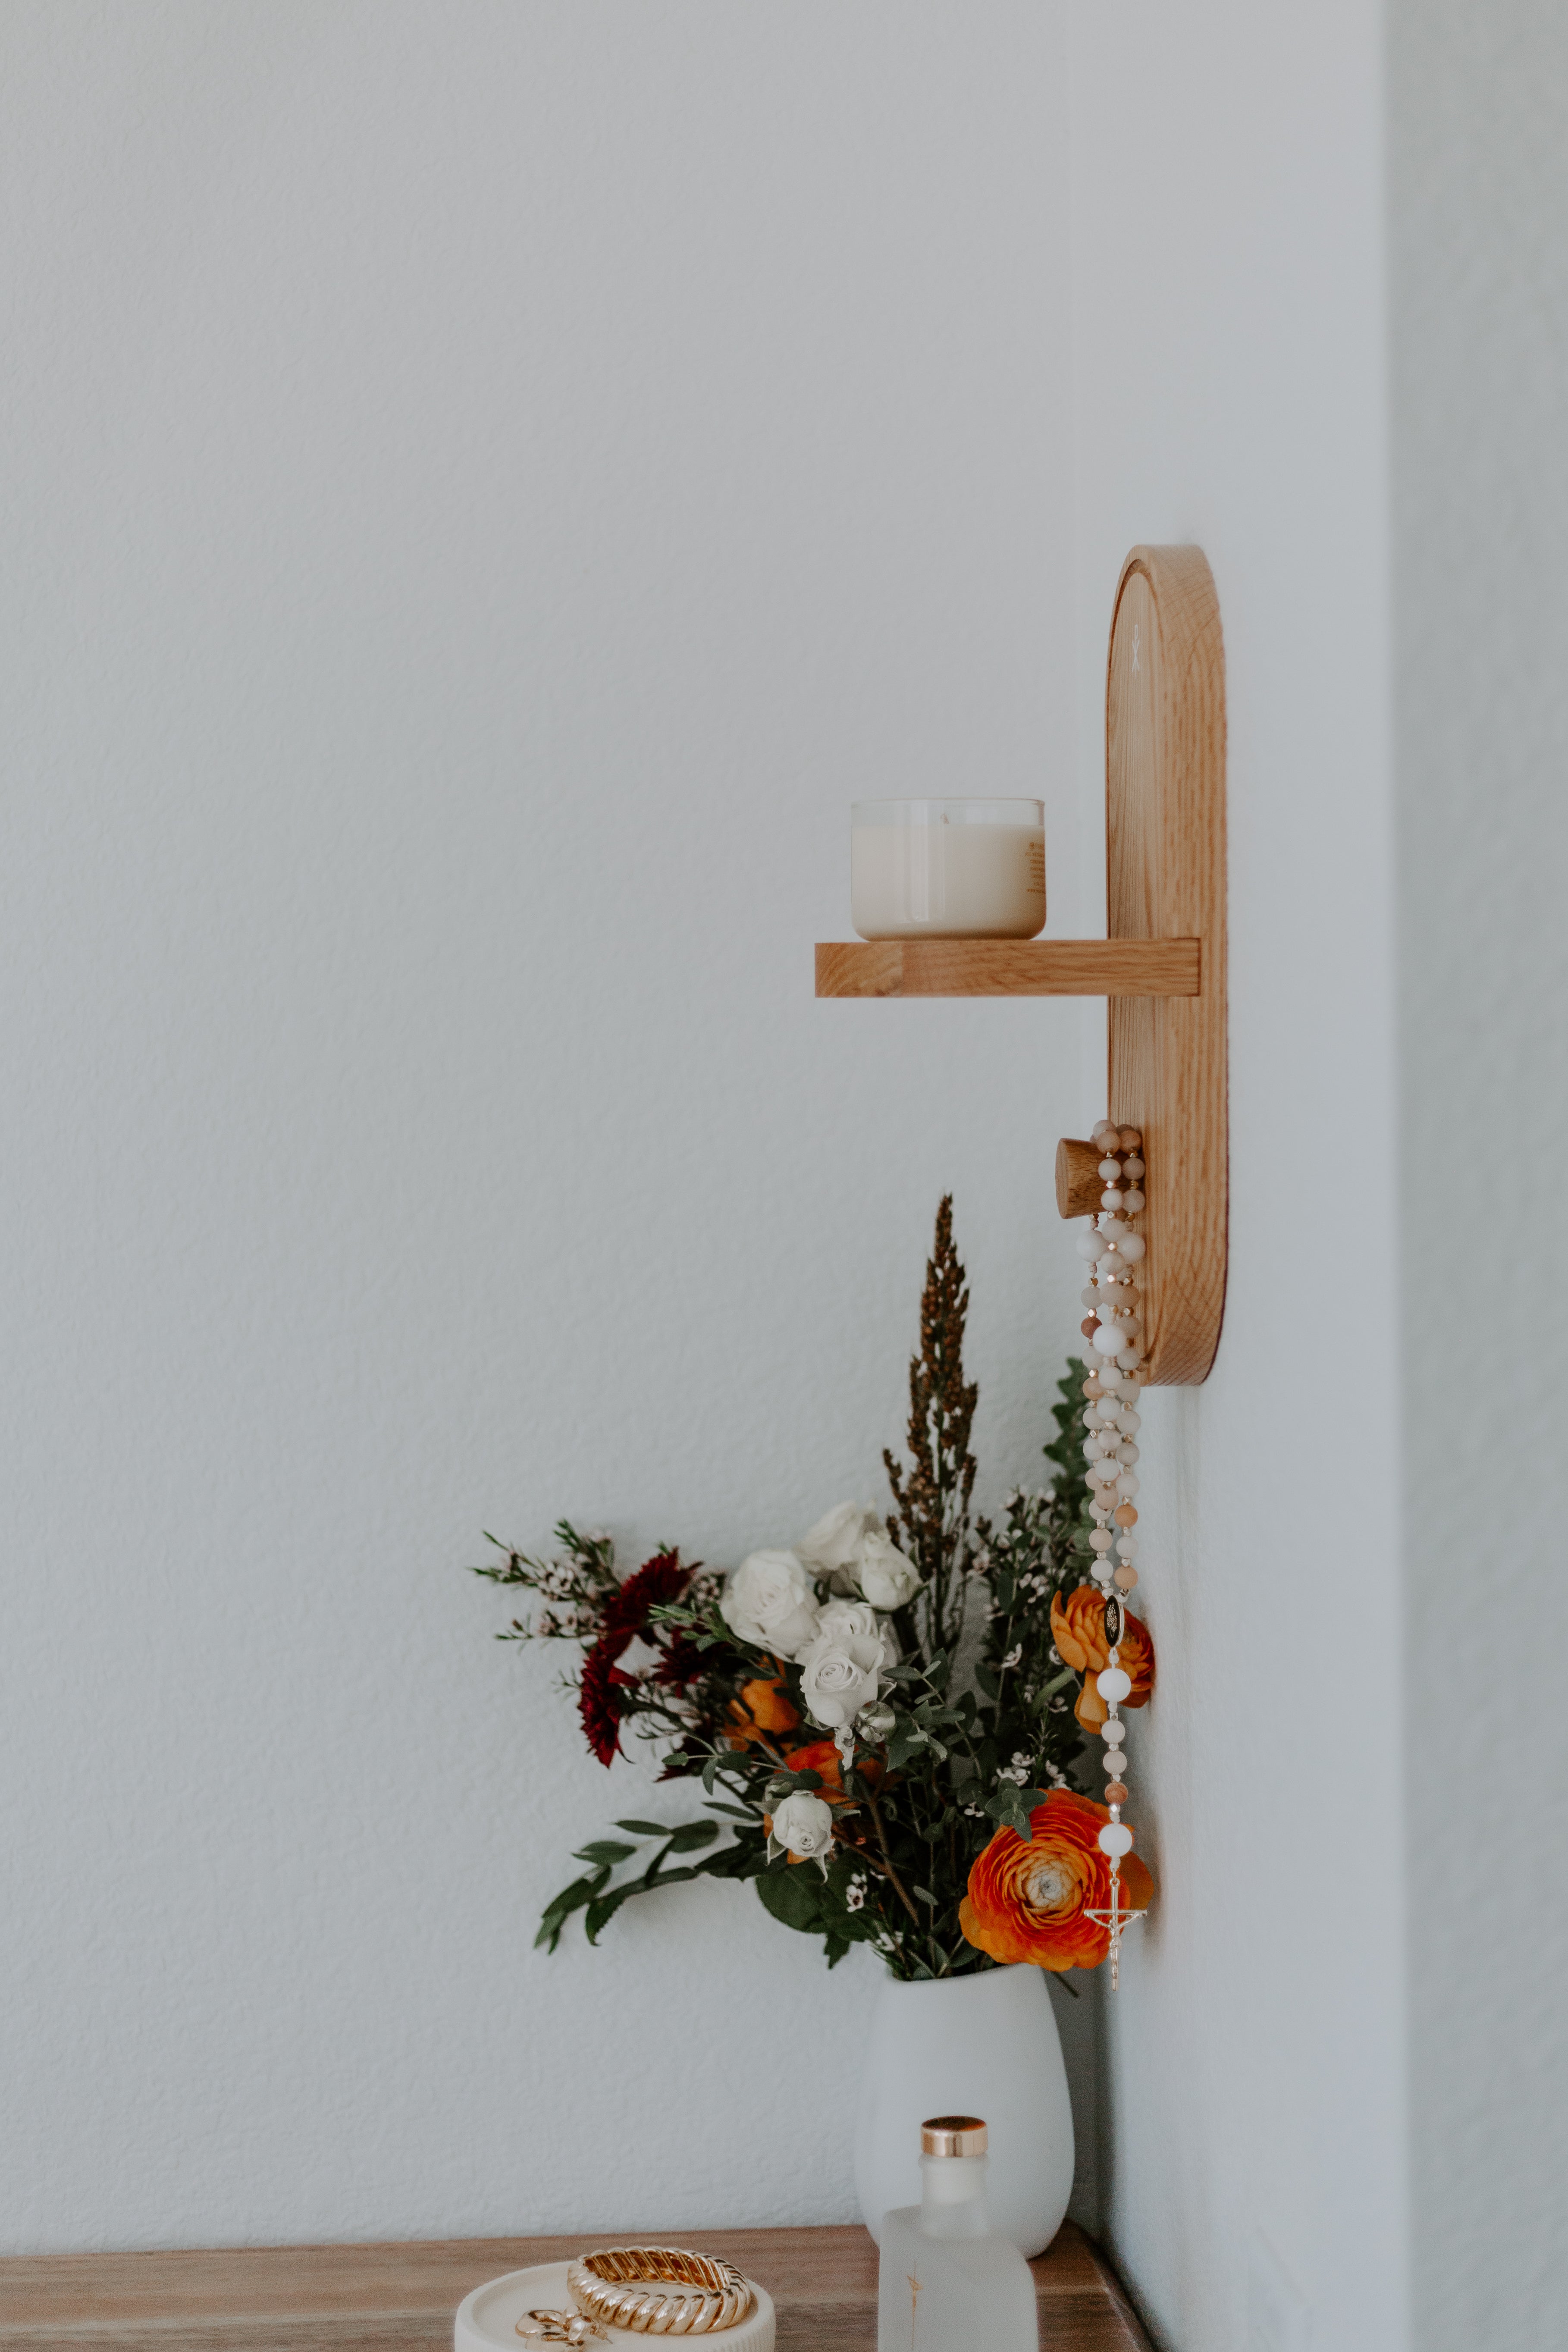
[816,548,1229,1385]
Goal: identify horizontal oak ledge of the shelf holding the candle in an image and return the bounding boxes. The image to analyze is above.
[816,938,1204,997]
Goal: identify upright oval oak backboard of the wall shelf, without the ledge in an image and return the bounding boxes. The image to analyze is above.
[1105,548,1229,1385]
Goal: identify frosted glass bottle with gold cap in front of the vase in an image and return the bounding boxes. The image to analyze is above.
[877,2114,1039,2352]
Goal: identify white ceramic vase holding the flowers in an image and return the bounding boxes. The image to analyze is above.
[856,1966,1072,2255]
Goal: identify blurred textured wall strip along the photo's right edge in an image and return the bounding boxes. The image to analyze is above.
[1389,0,1568,2352]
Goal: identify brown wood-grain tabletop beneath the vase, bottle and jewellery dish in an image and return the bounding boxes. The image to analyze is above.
[0,2223,1147,2352]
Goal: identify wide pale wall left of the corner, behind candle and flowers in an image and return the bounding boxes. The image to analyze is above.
[0,0,1091,2249]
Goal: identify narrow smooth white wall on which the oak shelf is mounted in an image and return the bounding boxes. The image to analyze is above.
[1072,0,1401,2352]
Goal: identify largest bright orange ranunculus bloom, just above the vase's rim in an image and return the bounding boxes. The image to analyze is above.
[959,1788,1154,1969]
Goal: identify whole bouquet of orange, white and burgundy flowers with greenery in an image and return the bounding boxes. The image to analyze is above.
[475,1200,1154,1980]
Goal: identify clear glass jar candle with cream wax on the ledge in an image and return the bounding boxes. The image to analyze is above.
[849,800,1046,938]
